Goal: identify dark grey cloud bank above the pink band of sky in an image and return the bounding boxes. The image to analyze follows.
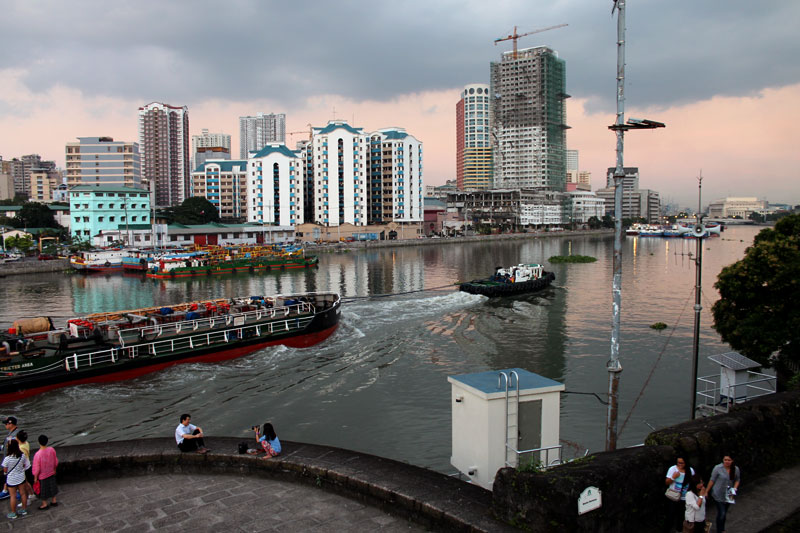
[0,0,800,110]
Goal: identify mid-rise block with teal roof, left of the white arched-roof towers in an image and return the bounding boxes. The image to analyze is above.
[191,159,247,221]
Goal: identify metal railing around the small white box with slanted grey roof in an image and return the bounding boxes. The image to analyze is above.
[697,370,778,414]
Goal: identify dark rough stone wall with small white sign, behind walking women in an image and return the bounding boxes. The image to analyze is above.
[493,392,800,532]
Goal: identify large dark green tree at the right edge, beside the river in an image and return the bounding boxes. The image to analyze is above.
[711,215,800,384]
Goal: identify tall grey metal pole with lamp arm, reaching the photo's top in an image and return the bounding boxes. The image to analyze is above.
[606,0,664,451]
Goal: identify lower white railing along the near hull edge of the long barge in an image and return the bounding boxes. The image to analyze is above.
[64,315,314,372]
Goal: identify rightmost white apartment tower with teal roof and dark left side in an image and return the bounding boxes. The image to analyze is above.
[368,128,424,224]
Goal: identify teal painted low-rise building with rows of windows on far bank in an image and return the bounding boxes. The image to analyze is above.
[69,185,152,246]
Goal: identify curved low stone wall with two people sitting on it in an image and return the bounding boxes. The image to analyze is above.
[53,437,513,532]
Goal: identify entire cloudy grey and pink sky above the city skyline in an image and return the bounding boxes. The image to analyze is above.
[0,0,800,206]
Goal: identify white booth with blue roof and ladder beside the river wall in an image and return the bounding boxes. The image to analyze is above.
[447,368,564,490]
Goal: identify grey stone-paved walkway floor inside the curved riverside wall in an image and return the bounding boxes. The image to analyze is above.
[0,474,425,533]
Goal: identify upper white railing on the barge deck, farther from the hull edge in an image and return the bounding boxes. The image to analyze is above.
[117,302,314,347]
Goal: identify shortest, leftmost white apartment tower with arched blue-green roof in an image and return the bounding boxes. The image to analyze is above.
[247,143,304,226]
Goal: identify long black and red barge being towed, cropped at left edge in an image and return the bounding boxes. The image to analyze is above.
[0,293,341,402]
